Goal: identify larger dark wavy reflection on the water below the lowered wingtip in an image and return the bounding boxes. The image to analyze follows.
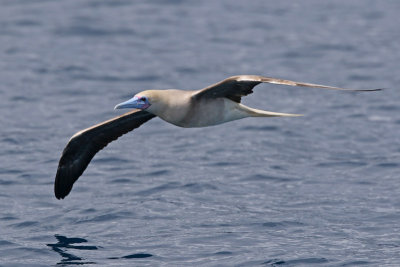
[47,235,98,265]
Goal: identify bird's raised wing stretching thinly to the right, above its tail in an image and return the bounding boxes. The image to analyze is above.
[193,75,382,103]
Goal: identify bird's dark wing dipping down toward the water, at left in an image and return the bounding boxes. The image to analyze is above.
[54,110,155,199]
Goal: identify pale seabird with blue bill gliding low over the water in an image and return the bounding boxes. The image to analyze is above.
[54,75,382,199]
